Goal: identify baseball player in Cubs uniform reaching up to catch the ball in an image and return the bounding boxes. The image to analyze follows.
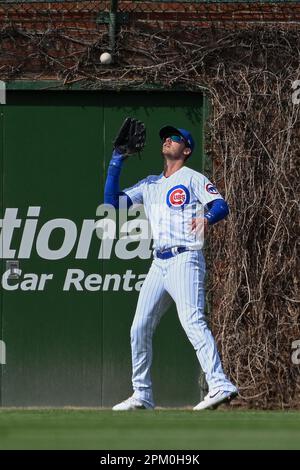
[104,118,238,411]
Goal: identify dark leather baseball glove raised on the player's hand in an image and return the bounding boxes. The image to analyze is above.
[113,117,146,156]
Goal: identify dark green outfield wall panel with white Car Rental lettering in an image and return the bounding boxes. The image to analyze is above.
[0,89,206,407]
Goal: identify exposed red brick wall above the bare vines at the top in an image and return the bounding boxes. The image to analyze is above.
[0,1,300,79]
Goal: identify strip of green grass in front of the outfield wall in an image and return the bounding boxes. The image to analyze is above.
[0,409,300,450]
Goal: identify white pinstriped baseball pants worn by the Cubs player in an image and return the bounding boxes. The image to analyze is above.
[130,250,236,406]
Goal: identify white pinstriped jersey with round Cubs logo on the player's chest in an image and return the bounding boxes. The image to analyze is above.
[123,166,222,250]
